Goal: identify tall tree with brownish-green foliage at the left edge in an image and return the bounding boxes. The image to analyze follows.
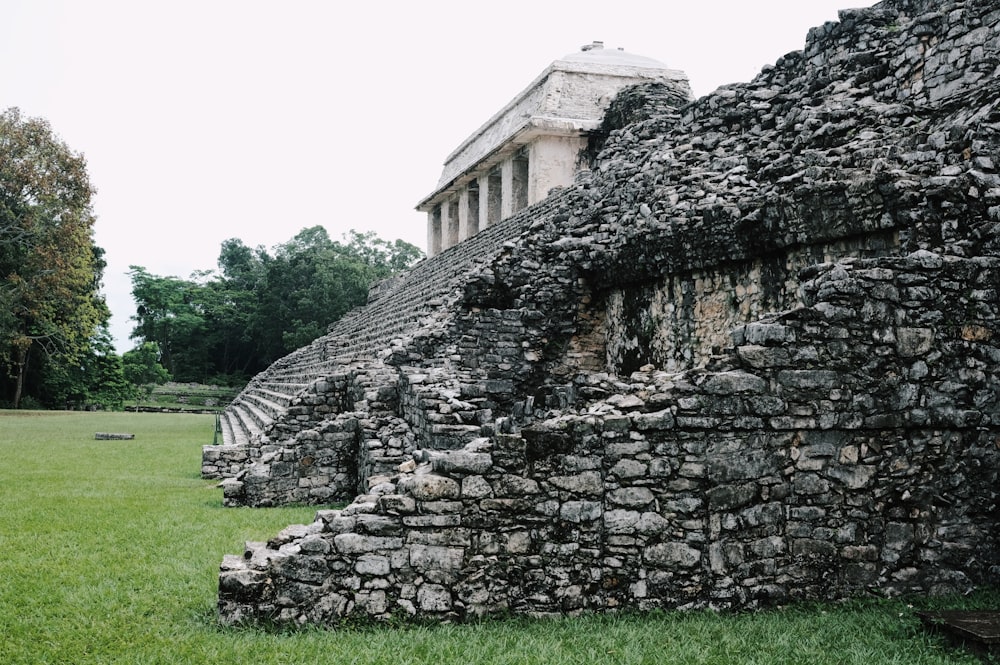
[0,108,110,408]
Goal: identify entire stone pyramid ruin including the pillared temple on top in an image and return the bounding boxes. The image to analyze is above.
[202,0,1000,626]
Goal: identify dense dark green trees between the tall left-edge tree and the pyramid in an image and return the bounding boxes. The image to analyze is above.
[130,226,422,385]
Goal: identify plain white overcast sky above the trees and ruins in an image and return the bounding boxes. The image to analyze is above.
[0,0,874,352]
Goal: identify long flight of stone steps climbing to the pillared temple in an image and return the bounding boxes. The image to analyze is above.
[202,190,569,478]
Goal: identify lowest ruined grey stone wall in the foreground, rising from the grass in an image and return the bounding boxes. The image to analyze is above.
[220,252,1000,624]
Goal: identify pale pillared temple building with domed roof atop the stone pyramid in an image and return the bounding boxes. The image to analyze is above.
[417,42,691,256]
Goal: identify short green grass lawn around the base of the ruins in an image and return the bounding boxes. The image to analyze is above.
[0,411,1000,665]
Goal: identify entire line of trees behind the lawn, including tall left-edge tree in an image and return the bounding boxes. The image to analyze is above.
[0,108,421,408]
